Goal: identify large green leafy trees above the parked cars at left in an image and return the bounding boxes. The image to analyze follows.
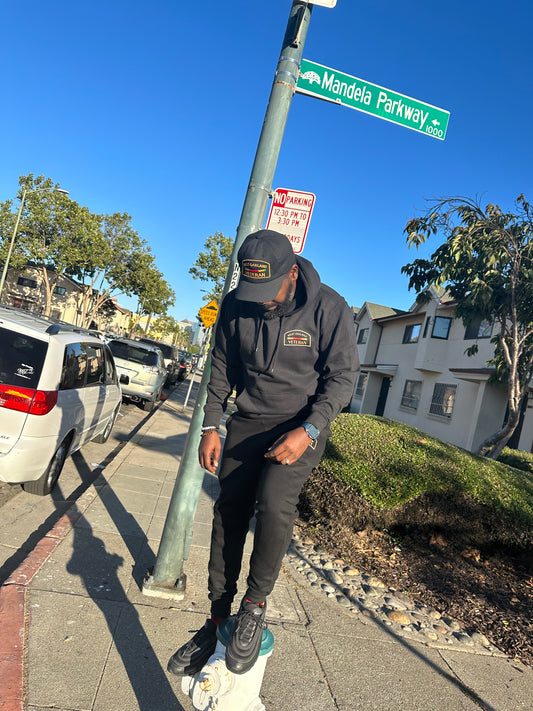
[0,174,175,325]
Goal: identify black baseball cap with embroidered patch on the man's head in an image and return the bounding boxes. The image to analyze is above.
[235,230,296,303]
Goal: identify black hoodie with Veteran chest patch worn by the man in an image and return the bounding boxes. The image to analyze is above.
[204,257,359,430]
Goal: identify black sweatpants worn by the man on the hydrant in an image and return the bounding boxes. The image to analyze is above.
[208,414,329,617]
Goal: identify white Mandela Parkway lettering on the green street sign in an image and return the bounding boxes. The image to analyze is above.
[309,71,444,138]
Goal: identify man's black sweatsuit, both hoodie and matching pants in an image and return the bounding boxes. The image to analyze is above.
[204,257,359,617]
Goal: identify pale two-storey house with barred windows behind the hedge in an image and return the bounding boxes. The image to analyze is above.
[351,288,533,452]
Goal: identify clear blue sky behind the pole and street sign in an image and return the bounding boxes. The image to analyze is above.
[0,0,533,319]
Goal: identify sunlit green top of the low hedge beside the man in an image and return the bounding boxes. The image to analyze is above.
[320,414,533,526]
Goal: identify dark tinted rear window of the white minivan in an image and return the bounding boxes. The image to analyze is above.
[0,327,48,389]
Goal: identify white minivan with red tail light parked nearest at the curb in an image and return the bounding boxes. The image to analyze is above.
[0,306,122,496]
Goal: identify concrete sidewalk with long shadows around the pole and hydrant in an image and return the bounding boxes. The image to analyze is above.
[0,372,533,711]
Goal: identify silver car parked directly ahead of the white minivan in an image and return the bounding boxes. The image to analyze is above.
[108,338,167,412]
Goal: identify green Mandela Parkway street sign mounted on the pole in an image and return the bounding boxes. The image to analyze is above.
[296,59,450,141]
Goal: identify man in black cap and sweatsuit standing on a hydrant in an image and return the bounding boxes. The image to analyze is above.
[168,230,358,675]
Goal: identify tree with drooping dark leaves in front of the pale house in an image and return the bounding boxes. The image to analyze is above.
[402,195,533,459]
